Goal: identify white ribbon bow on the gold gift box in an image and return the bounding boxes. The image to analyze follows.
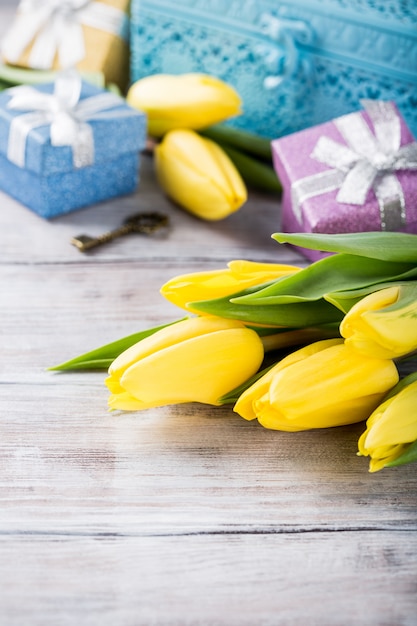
[2,0,126,70]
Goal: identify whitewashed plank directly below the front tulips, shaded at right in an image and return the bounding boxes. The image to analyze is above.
[0,374,417,535]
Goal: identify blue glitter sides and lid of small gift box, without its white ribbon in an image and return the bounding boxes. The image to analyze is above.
[0,82,146,218]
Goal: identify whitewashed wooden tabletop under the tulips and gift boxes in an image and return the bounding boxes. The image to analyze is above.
[0,4,417,626]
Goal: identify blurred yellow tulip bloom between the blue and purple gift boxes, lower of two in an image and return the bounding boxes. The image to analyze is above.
[155,130,247,220]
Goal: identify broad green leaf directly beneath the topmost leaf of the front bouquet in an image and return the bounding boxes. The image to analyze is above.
[233,254,417,306]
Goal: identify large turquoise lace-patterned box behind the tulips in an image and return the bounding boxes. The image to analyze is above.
[131,0,417,138]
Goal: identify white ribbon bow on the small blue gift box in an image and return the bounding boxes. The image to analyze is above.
[5,70,130,168]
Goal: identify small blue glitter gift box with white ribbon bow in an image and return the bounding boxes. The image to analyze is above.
[0,70,146,218]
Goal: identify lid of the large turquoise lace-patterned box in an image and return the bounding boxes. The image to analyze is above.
[136,0,417,84]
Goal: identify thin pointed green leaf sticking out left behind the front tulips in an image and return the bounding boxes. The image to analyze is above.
[48,318,187,371]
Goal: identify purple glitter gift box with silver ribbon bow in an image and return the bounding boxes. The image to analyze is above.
[272,100,417,261]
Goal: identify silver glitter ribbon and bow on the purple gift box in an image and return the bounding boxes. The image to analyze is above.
[291,100,417,231]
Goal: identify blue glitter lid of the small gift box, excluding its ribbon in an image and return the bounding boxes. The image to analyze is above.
[0,81,146,176]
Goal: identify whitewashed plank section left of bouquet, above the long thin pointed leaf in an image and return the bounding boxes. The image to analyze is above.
[0,263,185,381]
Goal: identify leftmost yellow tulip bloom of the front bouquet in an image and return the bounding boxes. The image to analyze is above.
[106,317,264,411]
